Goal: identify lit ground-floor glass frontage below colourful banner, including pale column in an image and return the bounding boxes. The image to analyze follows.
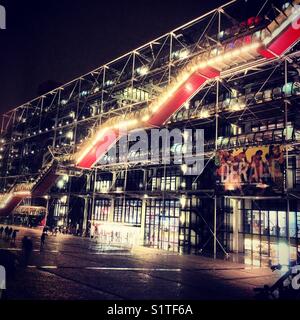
[224,200,300,266]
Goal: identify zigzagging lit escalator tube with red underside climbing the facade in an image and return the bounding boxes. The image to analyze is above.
[0,0,300,215]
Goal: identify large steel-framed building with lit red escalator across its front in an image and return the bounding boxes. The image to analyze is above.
[0,0,300,265]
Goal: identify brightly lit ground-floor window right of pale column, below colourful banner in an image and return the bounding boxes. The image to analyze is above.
[239,201,300,265]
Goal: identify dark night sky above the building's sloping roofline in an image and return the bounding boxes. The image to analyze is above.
[0,0,264,113]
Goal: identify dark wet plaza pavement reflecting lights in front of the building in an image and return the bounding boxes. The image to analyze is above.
[0,227,280,300]
